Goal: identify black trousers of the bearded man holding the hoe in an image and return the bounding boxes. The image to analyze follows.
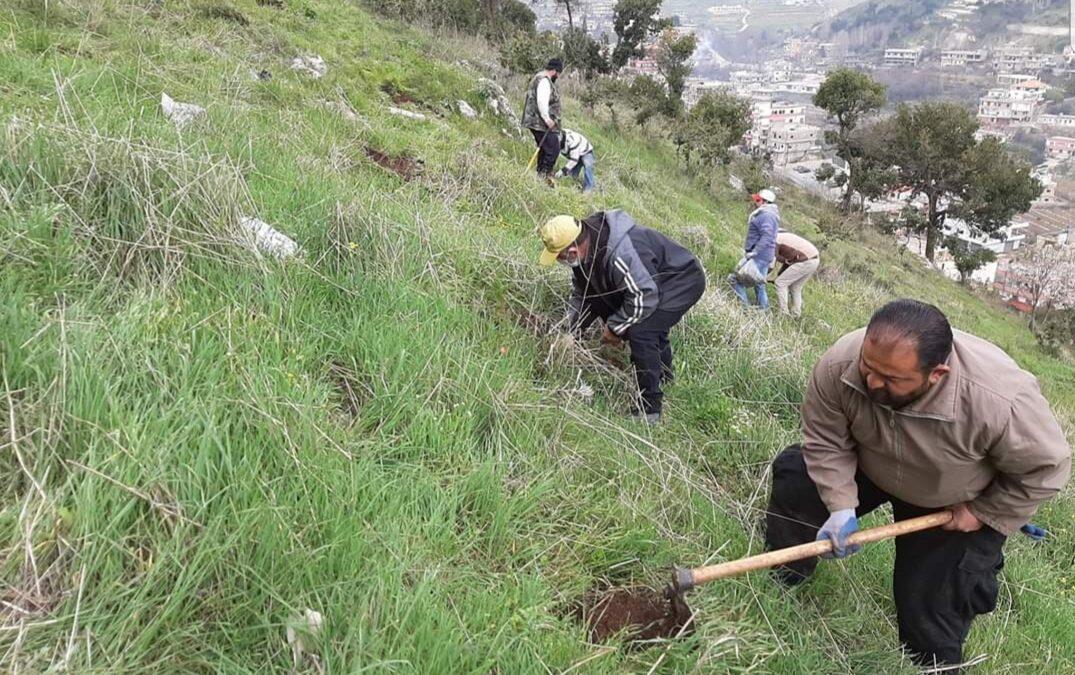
[765,445,1006,672]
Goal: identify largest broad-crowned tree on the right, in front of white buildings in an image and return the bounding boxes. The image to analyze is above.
[885,101,1041,260]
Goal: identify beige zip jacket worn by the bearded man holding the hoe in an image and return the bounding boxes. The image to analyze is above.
[802,329,1072,534]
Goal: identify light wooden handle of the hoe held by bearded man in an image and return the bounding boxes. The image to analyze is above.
[673,511,951,591]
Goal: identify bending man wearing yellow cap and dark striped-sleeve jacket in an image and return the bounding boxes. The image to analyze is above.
[539,210,705,423]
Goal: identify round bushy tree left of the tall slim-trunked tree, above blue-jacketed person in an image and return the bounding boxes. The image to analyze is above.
[674,91,750,166]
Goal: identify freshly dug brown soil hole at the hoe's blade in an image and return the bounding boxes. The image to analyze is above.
[575,586,693,646]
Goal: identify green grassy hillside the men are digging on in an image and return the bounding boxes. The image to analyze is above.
[0,0,1075,674]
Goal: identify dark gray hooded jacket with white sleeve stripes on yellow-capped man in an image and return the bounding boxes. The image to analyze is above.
[568,210,705,335]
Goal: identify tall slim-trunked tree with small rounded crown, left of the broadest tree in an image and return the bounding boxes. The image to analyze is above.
[814,68,885,213]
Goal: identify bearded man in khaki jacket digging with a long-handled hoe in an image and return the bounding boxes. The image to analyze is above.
[765,300,1071,672]
